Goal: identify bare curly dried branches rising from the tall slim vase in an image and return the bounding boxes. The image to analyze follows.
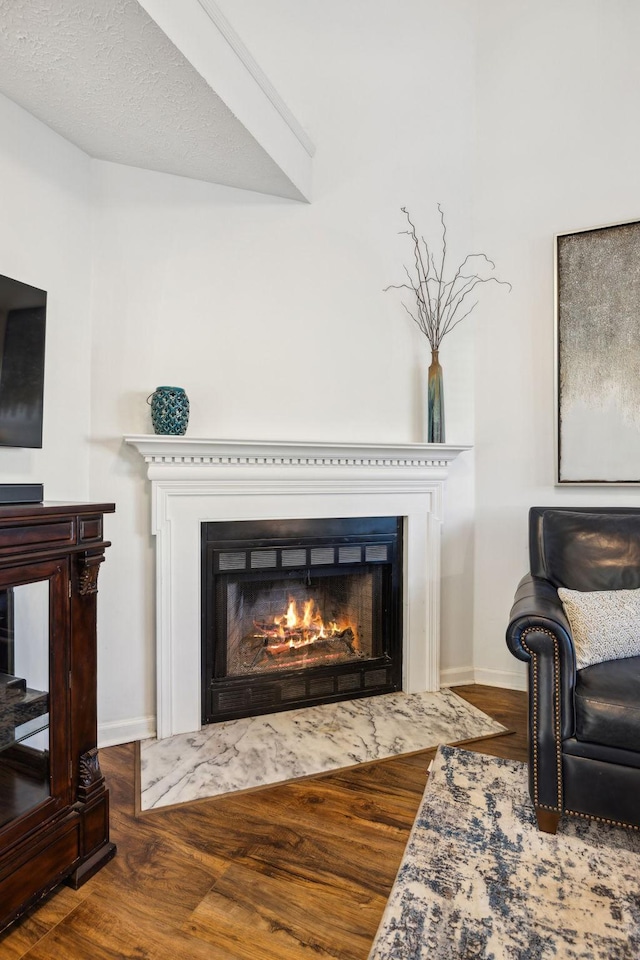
[384,204,511,350]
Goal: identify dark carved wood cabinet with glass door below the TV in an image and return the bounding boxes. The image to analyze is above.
[0,502,115,929]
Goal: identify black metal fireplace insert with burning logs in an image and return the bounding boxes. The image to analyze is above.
[202,517,402,723]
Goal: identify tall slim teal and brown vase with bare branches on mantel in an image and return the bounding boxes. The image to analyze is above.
[384,204,511,443]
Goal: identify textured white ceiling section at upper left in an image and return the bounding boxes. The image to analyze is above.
[0,0,304,199]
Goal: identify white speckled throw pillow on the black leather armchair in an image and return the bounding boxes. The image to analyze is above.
[558,587,640,670]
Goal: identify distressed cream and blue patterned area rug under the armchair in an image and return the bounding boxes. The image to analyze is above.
[369,747,640,960]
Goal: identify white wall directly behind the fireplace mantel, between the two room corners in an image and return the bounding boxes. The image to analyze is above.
[91,0,474,743]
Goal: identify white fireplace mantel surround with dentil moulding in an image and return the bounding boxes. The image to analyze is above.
[125,436,470,738]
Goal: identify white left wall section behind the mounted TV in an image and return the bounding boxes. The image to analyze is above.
[0,96,91,500]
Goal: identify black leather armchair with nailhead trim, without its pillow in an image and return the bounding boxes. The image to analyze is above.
[507,507,640,833]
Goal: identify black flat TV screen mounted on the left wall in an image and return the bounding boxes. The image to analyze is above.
[0,276,47,447]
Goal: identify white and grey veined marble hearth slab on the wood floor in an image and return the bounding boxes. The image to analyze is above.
[140,689,506,810]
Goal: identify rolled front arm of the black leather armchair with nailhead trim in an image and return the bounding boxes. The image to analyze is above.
[506,574,576,811]
